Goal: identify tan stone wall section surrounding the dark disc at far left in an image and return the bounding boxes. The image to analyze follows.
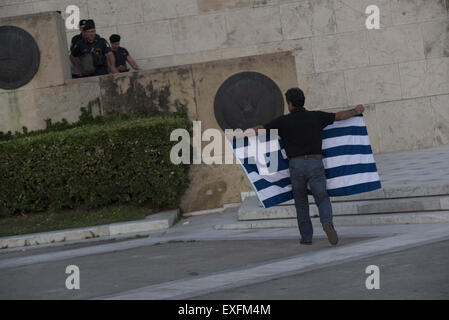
[0,11,72,132]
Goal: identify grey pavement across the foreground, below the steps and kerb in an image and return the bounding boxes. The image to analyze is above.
[0,209,449,299]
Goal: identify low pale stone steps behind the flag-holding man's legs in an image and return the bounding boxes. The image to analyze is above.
[216,147,449,229]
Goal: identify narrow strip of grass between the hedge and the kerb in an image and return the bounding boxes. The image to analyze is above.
[0,205,153,237]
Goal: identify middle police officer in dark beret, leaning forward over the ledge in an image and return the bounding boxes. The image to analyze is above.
[70,20,118,77]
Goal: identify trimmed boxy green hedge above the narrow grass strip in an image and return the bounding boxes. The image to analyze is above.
[0,116,191,216]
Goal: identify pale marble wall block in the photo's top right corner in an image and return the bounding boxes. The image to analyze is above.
[391,0,447,24]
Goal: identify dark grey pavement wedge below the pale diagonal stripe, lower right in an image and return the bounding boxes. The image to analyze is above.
[191,241,449,300]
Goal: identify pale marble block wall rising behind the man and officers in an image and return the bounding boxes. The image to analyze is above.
[0,0,449,153]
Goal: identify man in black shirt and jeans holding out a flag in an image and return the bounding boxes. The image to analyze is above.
[253,88,365,245]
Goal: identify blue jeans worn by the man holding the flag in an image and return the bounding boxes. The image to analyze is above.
[290,158,333,241]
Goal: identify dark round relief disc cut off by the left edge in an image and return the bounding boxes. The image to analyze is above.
[0,26,40,89]
